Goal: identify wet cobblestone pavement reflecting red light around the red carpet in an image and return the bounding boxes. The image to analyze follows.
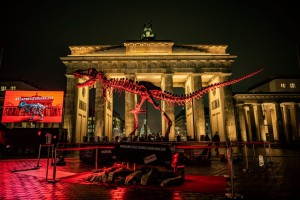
[0,145,300,200]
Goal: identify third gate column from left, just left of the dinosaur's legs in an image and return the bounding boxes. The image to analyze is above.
[125,74,136,137]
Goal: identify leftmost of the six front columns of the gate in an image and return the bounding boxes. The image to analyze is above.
[63,74,78,142]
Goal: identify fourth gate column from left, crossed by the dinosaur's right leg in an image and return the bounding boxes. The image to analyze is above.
[161,74,176,141]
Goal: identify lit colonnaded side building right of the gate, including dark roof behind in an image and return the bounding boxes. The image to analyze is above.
[233,76,300,143]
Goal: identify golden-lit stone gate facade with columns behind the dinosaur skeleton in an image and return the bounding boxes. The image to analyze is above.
[61,40,236,142]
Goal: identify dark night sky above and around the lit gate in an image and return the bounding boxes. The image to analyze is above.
[0,0,300,133]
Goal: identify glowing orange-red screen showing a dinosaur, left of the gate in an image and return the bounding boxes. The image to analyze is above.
[2,90,64,123]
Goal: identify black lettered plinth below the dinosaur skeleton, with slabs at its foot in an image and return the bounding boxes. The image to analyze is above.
[112,142,185,186]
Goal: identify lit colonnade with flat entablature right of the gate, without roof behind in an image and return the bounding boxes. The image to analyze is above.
[233,93,300,143]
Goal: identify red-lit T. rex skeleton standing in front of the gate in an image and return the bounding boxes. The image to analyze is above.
[73,68,263,141]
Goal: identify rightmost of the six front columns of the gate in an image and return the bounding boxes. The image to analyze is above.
[221,76,237,141]
